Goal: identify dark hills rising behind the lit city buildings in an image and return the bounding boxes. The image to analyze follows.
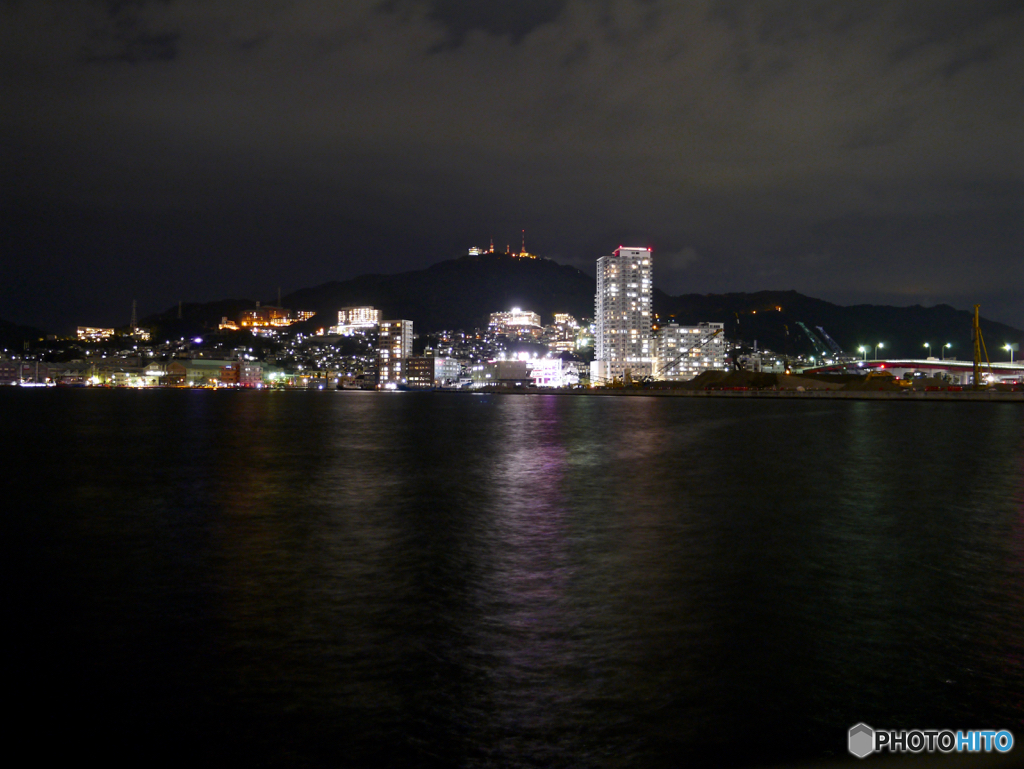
[144,254,1022,360]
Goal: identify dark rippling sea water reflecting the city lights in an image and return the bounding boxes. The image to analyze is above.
[8,388,1024,767]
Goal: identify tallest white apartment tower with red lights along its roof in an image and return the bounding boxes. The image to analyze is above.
[590,246,654,384]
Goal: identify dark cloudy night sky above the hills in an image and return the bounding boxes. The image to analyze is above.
[0,0,1024,331]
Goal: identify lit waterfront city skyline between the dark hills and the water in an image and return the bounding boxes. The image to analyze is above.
[0,276,1021,392]
